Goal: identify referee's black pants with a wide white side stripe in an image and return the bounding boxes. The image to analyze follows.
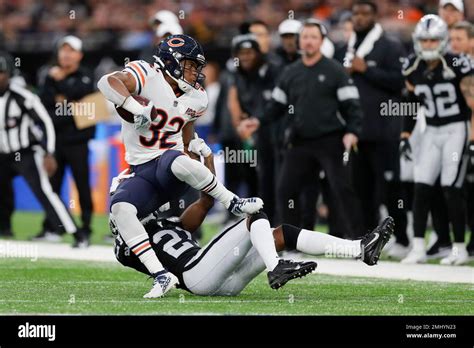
[0,146,77,233]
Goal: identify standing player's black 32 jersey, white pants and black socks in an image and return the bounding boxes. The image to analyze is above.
[404,53,474,243]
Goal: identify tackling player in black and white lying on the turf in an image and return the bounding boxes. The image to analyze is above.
[111,137,394,295]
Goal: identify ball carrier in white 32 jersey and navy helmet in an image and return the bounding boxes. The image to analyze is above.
[98,35,263,297]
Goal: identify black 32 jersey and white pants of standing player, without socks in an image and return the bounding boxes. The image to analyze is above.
[404,54,474,188]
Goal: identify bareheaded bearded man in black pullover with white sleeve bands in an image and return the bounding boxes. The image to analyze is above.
[250,20,362,237]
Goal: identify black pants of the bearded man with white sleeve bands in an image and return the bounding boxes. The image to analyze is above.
[277,134,362,238]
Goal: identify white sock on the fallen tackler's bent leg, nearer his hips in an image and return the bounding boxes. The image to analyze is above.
[250,219,280,271]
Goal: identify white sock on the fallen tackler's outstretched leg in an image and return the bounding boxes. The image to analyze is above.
[296,229,361,257]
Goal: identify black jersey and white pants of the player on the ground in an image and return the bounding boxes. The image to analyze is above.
[112,215,265,295]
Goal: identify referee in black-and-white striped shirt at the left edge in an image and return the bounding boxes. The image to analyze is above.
[0,52,87,247]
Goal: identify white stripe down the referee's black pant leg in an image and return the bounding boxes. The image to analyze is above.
[33,149,77,233]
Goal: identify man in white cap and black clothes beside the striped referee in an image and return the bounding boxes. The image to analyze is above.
[38,36,95,239]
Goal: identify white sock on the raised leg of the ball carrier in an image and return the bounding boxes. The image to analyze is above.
[171,156,236,209]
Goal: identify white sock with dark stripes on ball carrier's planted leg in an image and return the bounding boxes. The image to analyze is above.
[111,202,164,274]
